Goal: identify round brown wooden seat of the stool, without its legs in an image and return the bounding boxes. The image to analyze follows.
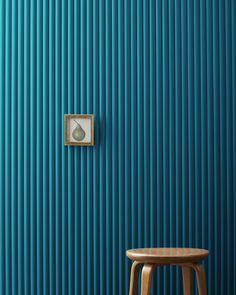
[126,248,209,264]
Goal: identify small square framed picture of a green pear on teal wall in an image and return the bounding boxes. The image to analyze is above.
[64,114,94,146]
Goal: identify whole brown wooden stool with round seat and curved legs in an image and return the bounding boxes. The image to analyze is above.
[126,248,209,295]
